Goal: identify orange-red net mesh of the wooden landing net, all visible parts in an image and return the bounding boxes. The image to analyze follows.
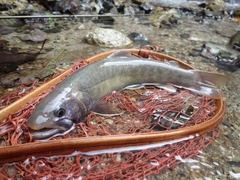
[0,47,220,179]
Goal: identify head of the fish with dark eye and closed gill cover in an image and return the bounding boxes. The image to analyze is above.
[27,88,90,139]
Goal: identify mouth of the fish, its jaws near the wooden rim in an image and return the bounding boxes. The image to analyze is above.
[30,119,74,140]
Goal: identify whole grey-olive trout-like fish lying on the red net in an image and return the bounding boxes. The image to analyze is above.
[27,50,228,140]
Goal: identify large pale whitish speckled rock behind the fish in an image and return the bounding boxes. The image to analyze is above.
[84,28,132,48]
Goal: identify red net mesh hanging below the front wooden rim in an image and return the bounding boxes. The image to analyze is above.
[0,128,219,180]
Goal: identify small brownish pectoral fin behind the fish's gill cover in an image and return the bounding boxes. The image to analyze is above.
[91,103,123,116]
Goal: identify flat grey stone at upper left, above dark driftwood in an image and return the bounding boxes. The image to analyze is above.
[21,29,48,42]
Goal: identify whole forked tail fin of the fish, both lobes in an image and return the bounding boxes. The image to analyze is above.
[187,70,229,99]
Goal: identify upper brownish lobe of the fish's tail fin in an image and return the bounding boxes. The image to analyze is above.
[193,70,229,87]
